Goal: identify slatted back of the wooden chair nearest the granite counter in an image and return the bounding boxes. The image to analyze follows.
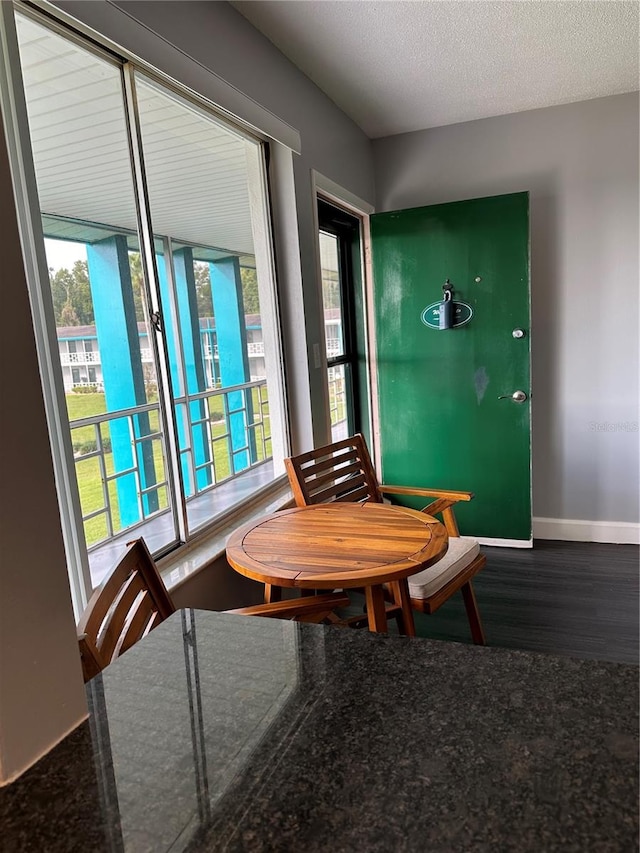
[78,539,175,681]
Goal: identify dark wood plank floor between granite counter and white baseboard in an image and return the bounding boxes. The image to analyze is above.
[362,540,640,664]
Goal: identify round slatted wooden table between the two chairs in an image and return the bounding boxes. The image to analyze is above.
[227,503,448,636]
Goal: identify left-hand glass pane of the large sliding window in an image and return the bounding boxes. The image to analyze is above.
[16,15,176,584]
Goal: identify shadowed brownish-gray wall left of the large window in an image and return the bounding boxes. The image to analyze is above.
[0,121,87,784]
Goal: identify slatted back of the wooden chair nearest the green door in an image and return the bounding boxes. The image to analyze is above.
[284,433,382,506]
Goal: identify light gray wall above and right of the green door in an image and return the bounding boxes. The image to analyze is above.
[374,94,638,522]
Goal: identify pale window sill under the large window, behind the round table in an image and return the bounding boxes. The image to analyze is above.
[158,481,292,591]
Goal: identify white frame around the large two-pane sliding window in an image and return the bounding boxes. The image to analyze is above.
[0,3,291,616]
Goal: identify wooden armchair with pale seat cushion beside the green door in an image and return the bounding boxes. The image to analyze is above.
[285,434,487,645]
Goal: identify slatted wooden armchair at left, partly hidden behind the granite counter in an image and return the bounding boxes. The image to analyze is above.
[77,539,349,682]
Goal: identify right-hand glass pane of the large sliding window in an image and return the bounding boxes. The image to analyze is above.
[136,74,279,530]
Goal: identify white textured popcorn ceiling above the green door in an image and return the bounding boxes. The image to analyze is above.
[233,0,640,138]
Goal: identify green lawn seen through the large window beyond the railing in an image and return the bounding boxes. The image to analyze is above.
[66,389,270,546]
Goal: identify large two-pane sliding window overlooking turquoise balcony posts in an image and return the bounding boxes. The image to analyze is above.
[6,13,286,592]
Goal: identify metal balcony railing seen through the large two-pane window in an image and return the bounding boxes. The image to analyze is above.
[69,380,272,549]
